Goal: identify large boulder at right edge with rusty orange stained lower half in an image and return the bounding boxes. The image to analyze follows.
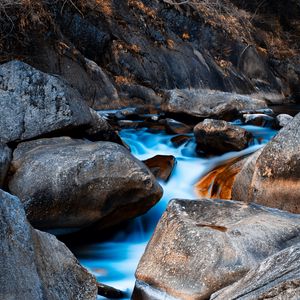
[232,114,300,213]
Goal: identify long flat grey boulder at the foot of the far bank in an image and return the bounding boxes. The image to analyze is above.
[162,89,267,120]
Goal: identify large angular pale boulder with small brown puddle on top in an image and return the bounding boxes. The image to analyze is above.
[136,199,300,299]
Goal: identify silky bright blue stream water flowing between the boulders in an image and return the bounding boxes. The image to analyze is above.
[72,126,276,294]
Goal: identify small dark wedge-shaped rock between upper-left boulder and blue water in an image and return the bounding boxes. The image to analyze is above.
[83,109,123,145]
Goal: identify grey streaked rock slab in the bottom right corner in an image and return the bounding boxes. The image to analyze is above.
[210,243,300,300]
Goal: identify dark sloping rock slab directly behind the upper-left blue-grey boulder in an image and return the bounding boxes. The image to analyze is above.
[33,41,120,109]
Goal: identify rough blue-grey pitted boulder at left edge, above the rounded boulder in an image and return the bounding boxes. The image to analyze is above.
[0,61,91,143]
